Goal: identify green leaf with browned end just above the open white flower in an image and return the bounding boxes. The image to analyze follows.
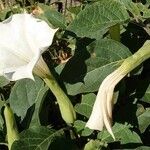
[38,3,66,29]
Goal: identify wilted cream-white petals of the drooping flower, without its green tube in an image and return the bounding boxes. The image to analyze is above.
[86,68,126,139]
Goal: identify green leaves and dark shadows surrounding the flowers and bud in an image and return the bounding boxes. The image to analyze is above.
[0,0,150,150]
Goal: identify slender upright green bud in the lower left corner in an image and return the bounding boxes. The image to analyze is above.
[4,104,19,150]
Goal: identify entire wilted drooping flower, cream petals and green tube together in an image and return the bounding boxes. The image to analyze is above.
[86,41,150,140]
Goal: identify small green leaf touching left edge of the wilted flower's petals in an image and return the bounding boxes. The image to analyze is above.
[75,93,96,118]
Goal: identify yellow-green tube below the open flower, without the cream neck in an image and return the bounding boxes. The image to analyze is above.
[43,74,76,123]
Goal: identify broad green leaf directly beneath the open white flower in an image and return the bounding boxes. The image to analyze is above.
[9,77,48,119]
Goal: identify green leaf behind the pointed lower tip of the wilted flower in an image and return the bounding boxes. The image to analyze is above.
[97,123,142,144]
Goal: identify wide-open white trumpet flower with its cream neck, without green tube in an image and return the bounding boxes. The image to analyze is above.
[0,13,57,81]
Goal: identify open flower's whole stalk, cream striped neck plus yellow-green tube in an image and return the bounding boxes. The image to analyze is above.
[33,57,76,123]
